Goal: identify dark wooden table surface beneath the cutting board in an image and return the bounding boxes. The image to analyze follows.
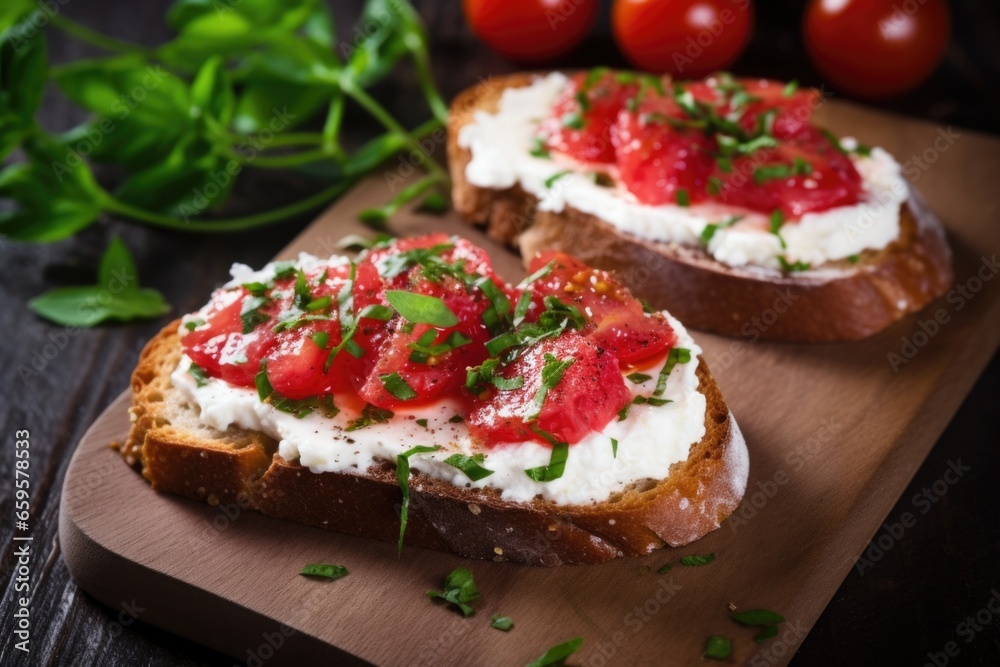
[0,0,1000,666]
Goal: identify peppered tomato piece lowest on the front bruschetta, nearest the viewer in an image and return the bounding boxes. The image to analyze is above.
[466,333,632,446]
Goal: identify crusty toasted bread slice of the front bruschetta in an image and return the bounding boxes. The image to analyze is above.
[121,321,749,566]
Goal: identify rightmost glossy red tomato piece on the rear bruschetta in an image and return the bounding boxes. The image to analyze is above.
[719,129,862,219]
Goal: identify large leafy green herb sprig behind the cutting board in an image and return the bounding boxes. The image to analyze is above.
[0,0,448,247]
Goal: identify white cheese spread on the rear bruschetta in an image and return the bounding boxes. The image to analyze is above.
[458,72,907,270]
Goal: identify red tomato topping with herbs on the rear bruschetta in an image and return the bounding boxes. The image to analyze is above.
[540,70,862,221]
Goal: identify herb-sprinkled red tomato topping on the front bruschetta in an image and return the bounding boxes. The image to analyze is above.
[182,234,676,446]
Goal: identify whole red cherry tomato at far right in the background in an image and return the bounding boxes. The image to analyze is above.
[803,0,951,98]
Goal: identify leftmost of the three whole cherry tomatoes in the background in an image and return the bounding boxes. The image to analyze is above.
[462,0,598,62]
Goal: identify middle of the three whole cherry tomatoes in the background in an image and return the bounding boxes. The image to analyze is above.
[611,0,753,78]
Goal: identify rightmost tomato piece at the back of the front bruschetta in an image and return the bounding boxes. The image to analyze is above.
[529,251,677,368]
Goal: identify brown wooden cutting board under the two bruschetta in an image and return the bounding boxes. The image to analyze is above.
[59,103,1000,666]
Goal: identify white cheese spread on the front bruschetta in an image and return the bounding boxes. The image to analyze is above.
[171,257,720,505]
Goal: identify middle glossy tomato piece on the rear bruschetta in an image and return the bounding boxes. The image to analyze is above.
[612,98,715,206]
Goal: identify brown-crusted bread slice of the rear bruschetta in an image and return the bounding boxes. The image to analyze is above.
[448,74,953,342]
